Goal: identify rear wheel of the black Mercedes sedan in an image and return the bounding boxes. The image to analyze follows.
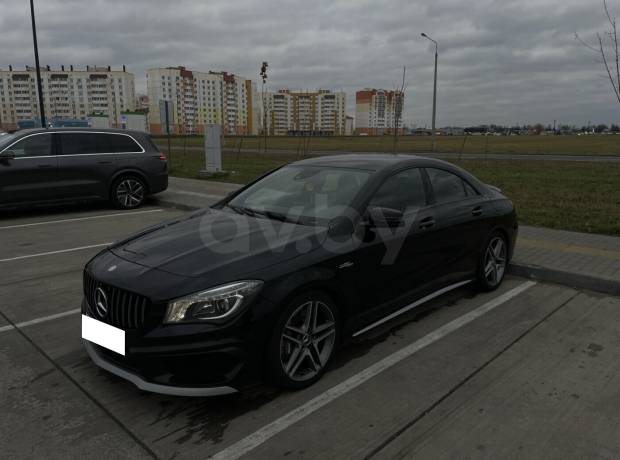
[476,231,508,291]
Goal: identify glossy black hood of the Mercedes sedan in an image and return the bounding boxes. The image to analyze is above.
[110,209,327,277]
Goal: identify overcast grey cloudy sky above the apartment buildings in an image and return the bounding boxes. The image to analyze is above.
[0,0,620,127]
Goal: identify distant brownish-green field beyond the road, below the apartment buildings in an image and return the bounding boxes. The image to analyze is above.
[156,135,620,155]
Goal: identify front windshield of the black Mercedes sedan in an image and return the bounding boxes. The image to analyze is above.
[227,165,371,223]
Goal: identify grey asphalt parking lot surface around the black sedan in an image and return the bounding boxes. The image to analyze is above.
[0,202,620,459]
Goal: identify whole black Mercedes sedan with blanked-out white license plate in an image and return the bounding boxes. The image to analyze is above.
[82,155,518,396]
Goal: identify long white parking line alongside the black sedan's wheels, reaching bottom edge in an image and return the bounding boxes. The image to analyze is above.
[210,281,536,460]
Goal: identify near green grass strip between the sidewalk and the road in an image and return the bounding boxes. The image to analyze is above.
[171,150,620,235]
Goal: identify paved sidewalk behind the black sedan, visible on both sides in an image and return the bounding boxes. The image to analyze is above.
[156,177,620,296]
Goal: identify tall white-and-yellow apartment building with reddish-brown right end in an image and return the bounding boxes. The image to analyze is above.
[147,67,259,135]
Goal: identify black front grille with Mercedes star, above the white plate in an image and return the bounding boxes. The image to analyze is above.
[84,271,149,330]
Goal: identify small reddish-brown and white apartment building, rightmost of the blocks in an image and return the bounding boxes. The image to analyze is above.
[355,88,405,136]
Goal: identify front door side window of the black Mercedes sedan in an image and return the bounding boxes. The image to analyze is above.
[368,168,426,212]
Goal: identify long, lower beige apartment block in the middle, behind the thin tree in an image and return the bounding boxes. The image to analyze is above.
[263,89,346,136]
